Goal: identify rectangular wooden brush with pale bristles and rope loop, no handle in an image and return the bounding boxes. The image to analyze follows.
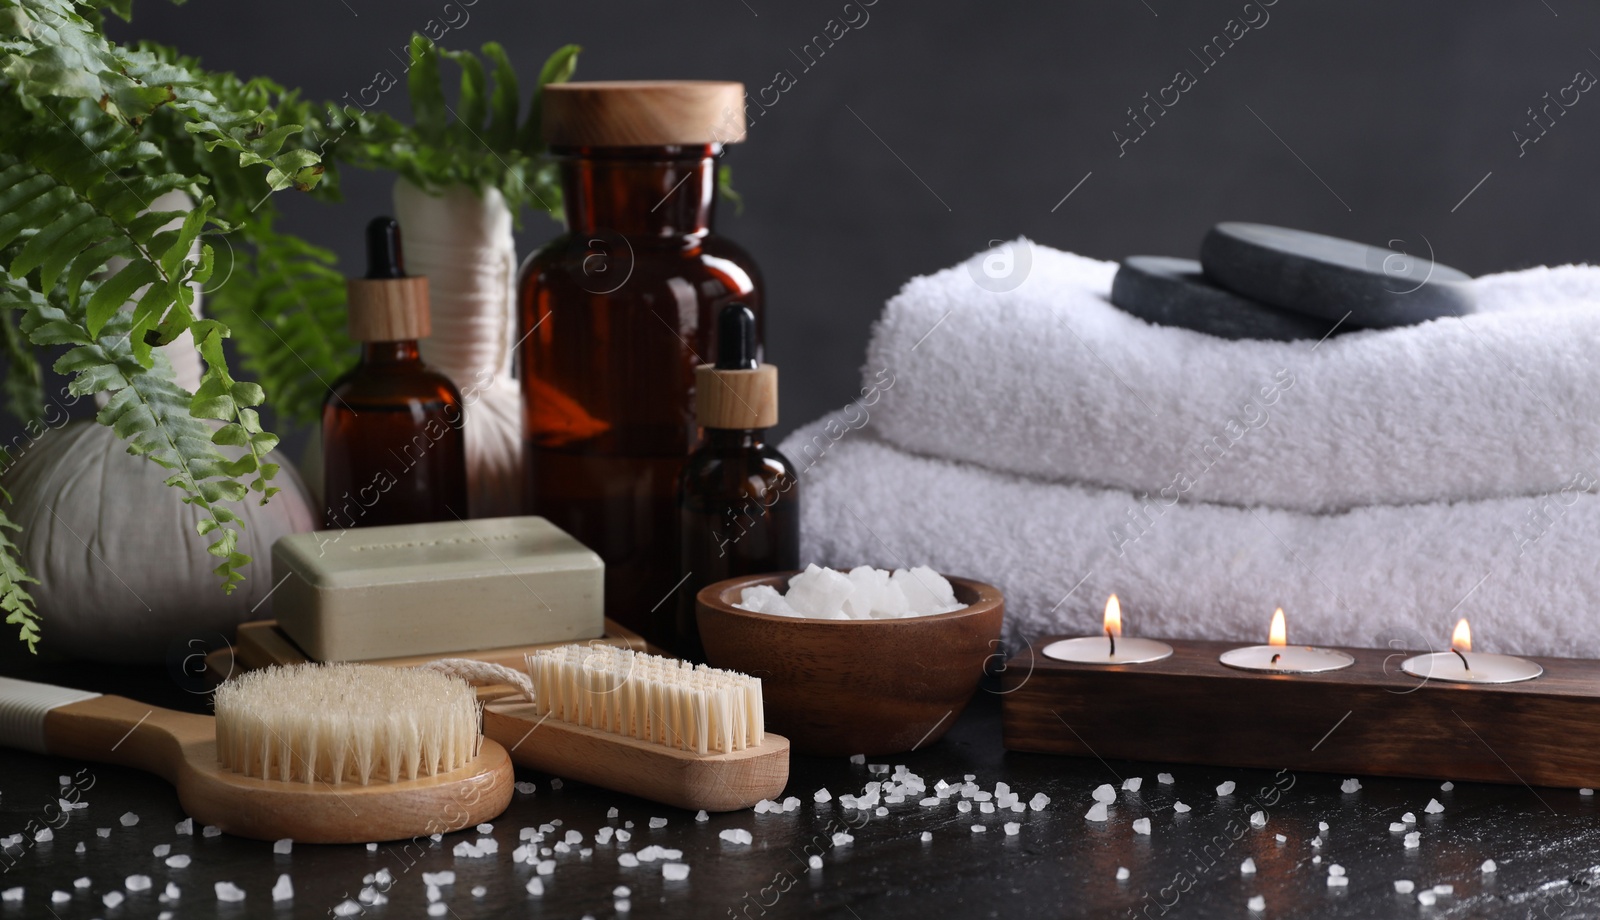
[434,645,789,811]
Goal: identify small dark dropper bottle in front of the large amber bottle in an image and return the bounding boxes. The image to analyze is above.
[674,304,800,661]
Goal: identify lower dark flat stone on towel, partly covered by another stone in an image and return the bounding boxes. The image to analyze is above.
[1110,256,1355,341]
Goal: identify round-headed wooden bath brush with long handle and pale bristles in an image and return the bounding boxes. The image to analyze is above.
[0,664,514,843]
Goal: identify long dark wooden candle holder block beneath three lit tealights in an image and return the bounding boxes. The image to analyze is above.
[1002,637,1600,787]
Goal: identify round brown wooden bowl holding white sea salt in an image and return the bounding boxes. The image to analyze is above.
[694,571,1005,755]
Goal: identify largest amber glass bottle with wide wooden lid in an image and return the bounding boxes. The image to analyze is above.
[517,83,763,643]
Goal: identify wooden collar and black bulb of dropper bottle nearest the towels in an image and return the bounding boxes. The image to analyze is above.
[694,304,778,430]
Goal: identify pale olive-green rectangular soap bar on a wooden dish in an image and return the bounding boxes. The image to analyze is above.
[272,517,605,661]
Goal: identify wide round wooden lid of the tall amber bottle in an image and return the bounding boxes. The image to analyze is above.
[544,80,744,147]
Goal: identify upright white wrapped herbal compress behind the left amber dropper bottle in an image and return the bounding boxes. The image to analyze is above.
[395,179,522,517]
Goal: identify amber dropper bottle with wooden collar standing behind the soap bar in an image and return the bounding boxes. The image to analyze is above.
[322,218,467,530]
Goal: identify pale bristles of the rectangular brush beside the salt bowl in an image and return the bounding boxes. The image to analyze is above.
[528,645,765,754]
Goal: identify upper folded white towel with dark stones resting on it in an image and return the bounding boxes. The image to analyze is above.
[867,240,1600,512]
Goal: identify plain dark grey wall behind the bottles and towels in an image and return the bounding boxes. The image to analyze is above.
[18,0,1600,441]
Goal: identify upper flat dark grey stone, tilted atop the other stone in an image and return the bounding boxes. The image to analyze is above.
[1200,222,1477,328]
